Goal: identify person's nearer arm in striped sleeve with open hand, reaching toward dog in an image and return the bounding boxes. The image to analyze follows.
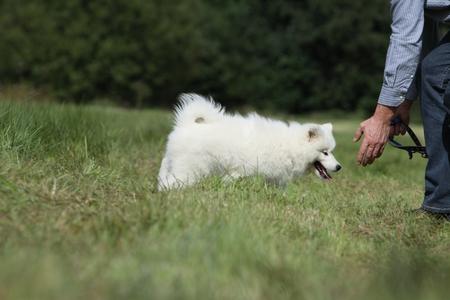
[354,0,425,166]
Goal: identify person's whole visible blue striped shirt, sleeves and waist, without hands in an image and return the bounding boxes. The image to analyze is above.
[378,0,450,107]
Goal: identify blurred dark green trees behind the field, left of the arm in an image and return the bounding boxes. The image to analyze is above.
[0,0,389,112]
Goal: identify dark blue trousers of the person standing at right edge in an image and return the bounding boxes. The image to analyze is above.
[420,32,450,213]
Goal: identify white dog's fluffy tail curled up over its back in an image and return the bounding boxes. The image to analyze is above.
[175,94,224,126]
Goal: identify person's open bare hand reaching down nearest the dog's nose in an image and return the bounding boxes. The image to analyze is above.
[353,104,396,166]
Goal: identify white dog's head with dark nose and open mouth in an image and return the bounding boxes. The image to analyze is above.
[306,123,342,180]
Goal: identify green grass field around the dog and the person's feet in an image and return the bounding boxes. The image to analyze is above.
[0,102,450,299]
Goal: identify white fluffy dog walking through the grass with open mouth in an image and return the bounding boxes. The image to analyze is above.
[158,94,341,190]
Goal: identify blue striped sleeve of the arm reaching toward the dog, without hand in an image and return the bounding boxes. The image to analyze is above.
[378,0,425,107]
